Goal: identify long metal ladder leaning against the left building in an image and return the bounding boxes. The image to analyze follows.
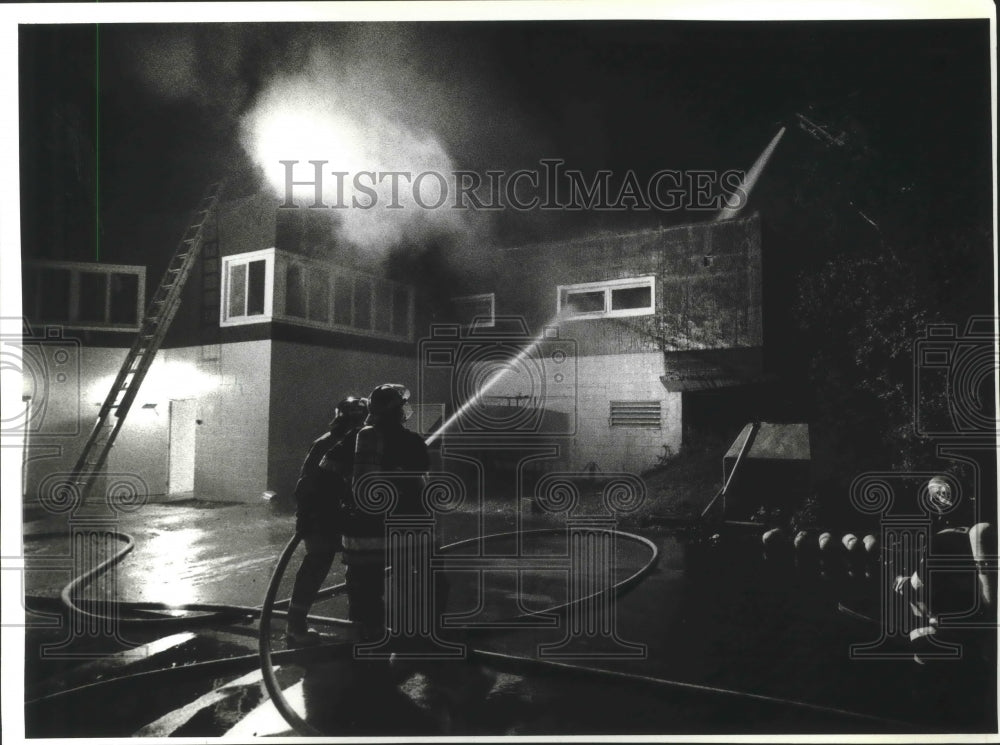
[71,181,224,504]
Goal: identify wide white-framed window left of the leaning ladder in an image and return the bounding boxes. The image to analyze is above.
[23,261,146,331]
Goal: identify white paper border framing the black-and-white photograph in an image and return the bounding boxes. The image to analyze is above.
[0,5,1000,743]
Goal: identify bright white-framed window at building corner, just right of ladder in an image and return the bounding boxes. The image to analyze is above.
[219,249,276,326]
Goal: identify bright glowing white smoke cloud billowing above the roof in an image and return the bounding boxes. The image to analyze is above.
[240,49,482,252]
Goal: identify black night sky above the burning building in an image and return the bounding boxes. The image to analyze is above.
[13,20,992,378]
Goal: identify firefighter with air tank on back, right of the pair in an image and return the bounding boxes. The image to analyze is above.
[343,383,430,642]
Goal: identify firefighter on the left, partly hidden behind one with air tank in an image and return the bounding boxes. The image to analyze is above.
[285,396,368,646]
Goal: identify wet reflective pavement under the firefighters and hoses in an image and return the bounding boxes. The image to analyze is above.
[19,502,996,737]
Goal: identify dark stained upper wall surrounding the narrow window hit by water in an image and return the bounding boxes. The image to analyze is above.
[488,214,763,354]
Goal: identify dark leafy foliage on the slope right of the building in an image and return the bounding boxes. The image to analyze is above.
[795,221,991,524]
